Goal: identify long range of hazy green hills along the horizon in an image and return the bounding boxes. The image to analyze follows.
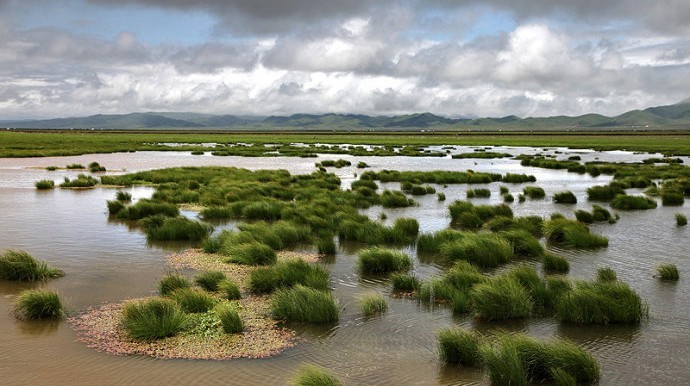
[0,100,690,131]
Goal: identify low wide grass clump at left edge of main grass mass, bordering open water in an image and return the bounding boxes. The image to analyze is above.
[141,215,213,241]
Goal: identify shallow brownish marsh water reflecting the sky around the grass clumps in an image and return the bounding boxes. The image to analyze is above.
[0,148,690,385]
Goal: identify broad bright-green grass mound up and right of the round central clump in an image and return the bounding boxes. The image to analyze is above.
[440,232,513,268]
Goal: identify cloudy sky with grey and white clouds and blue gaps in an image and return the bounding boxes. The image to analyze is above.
[0,0,690,119]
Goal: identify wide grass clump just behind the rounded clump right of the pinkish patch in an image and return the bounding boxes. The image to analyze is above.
[249,259,329,294]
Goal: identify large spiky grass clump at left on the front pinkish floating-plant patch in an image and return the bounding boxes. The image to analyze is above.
[122,298,187,340]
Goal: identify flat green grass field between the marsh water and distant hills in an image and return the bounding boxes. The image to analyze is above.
[0,131,690,157]
